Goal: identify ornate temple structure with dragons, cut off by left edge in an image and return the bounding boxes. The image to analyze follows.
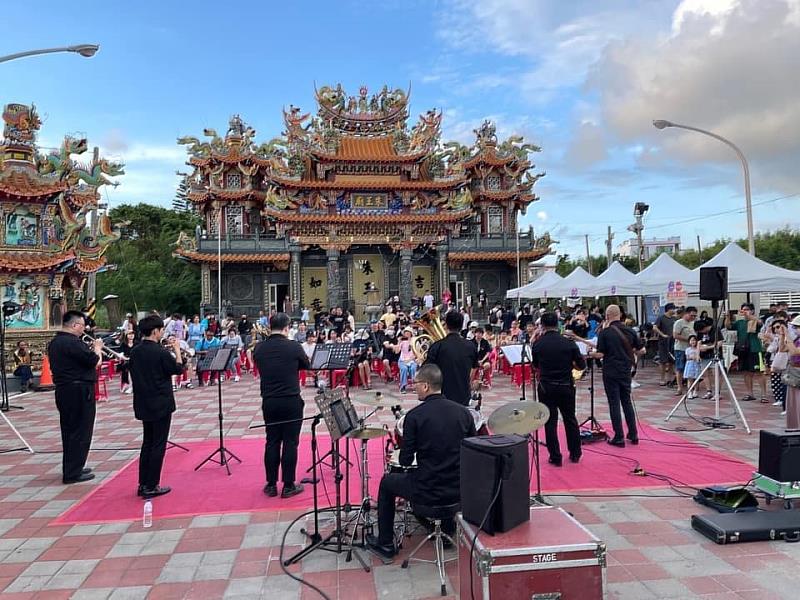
[0,104,124,364]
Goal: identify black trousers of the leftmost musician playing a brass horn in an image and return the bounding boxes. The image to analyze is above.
[56,382,96,482]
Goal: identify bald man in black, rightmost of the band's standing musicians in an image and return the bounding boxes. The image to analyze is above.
[592,304,642,448]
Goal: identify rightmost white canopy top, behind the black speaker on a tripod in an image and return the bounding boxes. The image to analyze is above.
[693,242,800,292]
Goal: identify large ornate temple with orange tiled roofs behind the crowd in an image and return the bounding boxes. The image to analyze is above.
[176,85,550,320]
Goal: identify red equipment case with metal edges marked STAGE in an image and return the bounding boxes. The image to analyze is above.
[457,506,606,600]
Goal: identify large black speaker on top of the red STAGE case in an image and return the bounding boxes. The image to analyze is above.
[461,435,530,535]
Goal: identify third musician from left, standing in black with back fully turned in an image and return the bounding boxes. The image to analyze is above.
[253,313,311,498]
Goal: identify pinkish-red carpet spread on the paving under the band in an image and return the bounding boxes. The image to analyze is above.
[53,426,754,524]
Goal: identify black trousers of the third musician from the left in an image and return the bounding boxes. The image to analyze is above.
[261,396,303,486]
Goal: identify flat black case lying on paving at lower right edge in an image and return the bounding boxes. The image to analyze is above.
[692,510,800,544]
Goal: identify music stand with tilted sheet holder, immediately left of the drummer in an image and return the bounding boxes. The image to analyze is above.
[283,390,370,573]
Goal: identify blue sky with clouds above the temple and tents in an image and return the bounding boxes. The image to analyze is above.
[0,0,800,255]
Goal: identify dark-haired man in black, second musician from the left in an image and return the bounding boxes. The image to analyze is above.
[128,315,183,498]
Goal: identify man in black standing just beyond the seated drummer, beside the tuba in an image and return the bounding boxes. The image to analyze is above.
[425,310,478,406]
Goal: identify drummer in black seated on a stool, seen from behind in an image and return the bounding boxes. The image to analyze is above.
[367,364,475,559]
